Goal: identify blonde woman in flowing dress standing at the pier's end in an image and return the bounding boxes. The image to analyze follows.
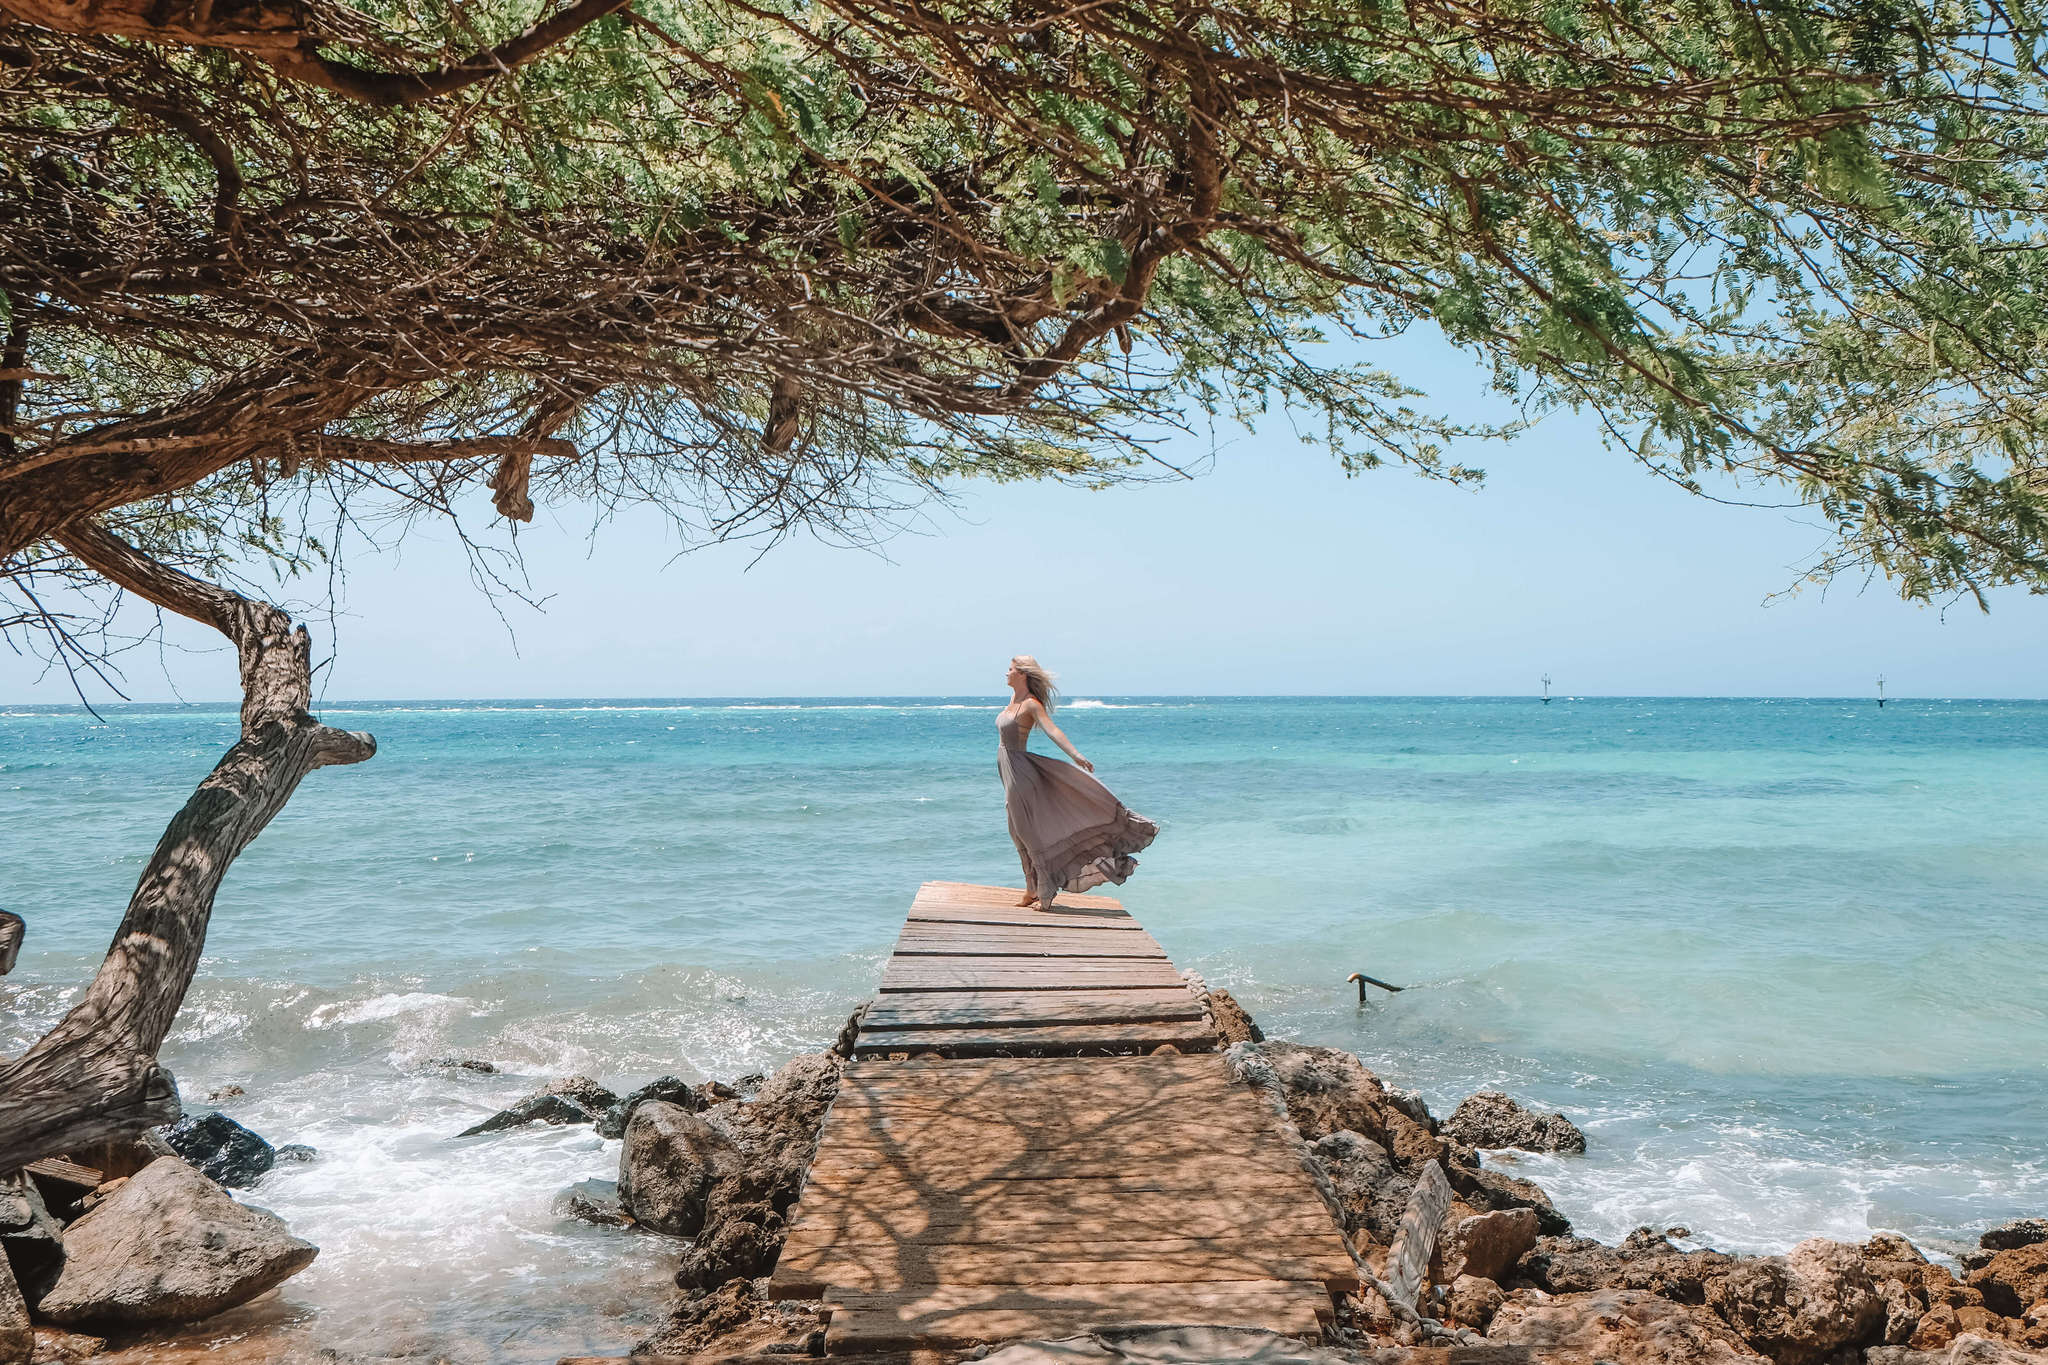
[995,655,1159,909]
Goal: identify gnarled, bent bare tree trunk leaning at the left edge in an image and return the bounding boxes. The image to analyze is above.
[0,522,377,1171]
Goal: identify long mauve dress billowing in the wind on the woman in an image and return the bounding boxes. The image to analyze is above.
[995,710,1159,905]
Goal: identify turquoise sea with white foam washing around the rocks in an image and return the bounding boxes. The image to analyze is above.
[0,698,2048,1359]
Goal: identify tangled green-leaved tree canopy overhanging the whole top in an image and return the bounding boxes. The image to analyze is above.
[0,0,2048,1169]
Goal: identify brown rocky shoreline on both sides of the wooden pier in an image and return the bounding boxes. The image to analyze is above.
[0,994,2048,1365]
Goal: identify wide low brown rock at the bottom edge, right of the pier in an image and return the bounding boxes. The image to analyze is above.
[1487,1289,1759,1365]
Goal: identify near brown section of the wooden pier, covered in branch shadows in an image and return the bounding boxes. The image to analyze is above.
[772,1056,1354,1351]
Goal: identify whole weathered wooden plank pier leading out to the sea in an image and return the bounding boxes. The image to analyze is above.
[770,882,1358,1355]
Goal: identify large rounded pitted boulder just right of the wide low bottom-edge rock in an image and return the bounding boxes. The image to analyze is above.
[1706,1238,1884,1365]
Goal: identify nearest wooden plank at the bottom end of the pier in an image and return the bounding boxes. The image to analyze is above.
[825,1279,1331,1355]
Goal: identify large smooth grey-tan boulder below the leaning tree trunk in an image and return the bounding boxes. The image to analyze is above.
[37,1158,319,1324]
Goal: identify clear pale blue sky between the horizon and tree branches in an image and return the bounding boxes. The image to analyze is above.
[0,340,2048,702]
